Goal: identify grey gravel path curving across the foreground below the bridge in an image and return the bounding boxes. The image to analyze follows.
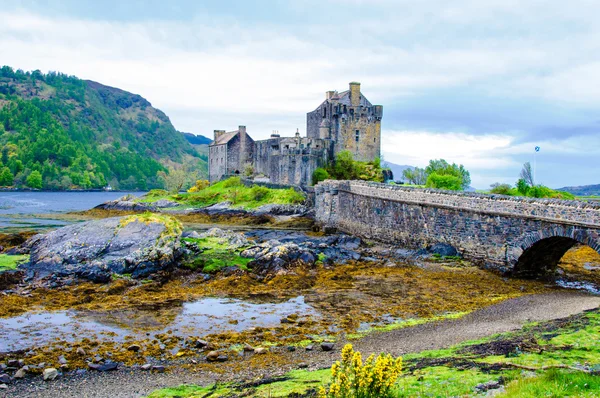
[5,290,600,398]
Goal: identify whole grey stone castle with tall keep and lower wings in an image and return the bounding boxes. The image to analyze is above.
[208,82,383,186]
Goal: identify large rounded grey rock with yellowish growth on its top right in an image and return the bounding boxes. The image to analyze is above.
[21,216,181,283]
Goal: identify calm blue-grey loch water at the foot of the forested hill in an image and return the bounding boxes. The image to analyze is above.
[0,192,143,230]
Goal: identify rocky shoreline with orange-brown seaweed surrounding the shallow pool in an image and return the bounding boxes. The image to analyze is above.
[0,197,596,396]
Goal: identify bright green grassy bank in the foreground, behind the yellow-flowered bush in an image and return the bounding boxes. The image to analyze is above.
[149,309,600,398]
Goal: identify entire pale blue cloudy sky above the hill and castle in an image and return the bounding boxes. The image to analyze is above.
[0,0,600,189]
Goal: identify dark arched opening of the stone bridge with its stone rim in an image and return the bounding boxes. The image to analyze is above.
[513,226,600,278]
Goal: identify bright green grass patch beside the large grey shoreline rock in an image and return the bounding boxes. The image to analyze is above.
[183,237,252,274]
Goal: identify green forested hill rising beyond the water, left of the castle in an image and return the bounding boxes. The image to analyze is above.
[0,66,207,189]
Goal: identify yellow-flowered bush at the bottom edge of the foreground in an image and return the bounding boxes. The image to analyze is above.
[319,344,402,398]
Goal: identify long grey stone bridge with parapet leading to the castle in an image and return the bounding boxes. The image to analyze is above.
[315,181,600,277]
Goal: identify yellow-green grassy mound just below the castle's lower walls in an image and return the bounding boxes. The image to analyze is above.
[139,177,306,209]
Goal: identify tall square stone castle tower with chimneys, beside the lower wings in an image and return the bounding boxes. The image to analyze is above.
[306,82,383,161]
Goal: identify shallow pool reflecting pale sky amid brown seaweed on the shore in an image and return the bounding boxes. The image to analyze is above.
[0,296,317,352]
